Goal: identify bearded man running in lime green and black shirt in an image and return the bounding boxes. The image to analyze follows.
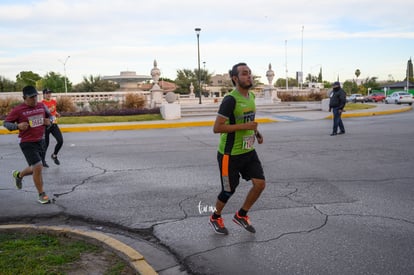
[210,63,265,234]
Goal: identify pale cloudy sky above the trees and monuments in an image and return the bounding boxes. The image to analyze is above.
[0,0,414,84]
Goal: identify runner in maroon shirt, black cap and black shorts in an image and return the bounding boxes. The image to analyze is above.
[3,86,50,204]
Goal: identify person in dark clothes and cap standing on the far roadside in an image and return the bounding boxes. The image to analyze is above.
[329,81,346,136]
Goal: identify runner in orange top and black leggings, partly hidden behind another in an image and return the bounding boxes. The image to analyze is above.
[42,89,63,167]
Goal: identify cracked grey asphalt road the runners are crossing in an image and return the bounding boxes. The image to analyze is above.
[0,110,414,274]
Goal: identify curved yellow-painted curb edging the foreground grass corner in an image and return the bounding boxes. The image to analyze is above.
[0,224,157,275]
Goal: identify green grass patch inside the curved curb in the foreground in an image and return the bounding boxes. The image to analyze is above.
[0,233,132,275]
